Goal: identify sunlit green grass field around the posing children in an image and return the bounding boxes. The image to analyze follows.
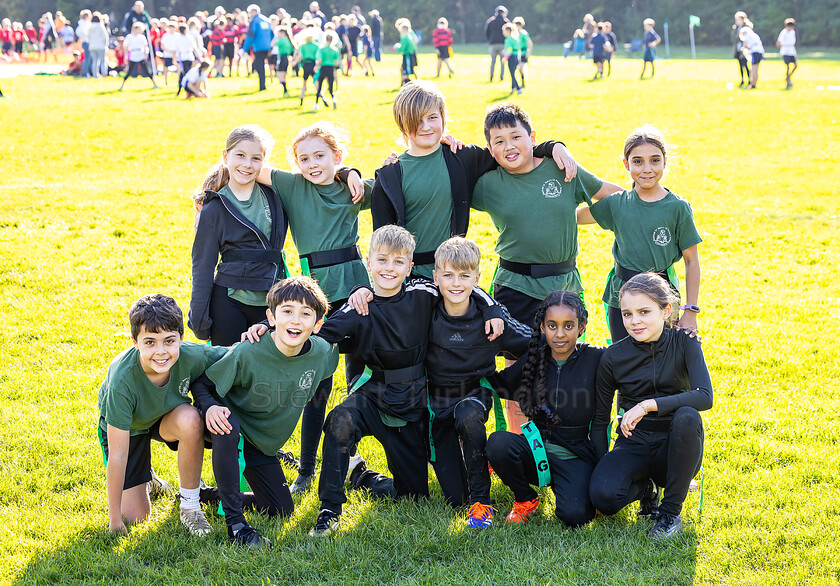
[0,47,840,585]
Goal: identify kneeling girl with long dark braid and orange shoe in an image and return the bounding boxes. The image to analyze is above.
[487,291,604,527]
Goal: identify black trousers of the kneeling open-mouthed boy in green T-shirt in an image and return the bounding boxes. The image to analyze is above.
[210,413,295,527]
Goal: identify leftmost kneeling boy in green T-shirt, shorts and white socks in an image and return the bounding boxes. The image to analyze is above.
[99,294,227,537]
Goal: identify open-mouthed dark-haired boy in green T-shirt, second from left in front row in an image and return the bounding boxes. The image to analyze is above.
[193,277,338,548]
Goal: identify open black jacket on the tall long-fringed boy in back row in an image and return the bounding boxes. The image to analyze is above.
[370,140,562,243]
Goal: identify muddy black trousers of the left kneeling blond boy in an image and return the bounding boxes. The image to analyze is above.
[318,390,429,513]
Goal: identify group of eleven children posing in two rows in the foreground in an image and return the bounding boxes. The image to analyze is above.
[99,81,712,547]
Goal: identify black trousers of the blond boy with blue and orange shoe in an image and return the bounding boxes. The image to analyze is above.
[432,397,490,507]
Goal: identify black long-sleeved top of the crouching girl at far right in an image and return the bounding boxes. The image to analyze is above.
[592,328,713,457]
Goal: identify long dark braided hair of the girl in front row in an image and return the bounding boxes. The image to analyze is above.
[519,291,589,425]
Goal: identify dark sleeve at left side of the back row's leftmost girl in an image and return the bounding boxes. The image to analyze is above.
[188,208,219,340]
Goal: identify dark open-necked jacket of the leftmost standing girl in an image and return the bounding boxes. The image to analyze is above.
[189,184,289,340]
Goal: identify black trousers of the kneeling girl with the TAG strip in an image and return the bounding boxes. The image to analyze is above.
[487,431,595,527]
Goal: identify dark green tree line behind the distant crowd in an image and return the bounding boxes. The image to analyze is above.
[0,0,840,49]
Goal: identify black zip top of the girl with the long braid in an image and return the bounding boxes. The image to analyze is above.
[490,337,606,462]
